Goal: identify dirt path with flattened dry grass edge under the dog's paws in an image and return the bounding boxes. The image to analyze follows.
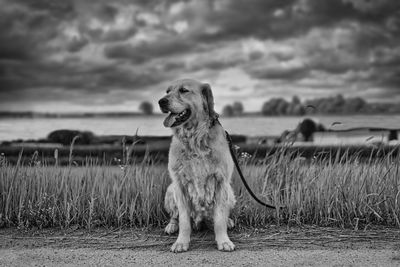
[0,227,400,266]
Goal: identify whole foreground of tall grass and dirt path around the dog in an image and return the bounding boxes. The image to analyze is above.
[0,140,400,266]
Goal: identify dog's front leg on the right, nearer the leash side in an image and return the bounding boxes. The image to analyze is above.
[214,185,235,251]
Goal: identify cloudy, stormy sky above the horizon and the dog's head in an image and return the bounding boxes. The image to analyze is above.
[0,0,400,113]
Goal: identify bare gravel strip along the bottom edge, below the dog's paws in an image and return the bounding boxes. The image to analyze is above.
[0,248,400,266]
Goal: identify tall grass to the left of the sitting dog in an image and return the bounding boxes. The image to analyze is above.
[0,152,168,228]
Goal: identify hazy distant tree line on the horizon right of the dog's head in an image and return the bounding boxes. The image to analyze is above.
[222,94,400,117]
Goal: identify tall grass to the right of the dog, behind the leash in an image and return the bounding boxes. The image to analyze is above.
[236,147,400,229]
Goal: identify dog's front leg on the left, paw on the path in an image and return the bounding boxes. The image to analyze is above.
[171,189,192,253]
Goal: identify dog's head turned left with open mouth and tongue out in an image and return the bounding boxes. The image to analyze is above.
[158,79,218,127]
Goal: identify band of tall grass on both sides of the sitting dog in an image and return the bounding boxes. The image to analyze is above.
[0,149,400,229]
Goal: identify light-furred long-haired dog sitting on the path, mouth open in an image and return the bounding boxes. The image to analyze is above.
[158,79,236,252]
